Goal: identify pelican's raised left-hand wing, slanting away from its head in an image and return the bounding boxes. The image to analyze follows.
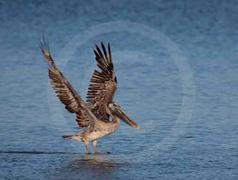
[41,38,96,128]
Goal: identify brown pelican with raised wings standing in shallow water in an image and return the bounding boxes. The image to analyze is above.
[41,39,140,153]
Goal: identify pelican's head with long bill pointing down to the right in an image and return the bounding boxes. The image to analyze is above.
[108,102,140,129]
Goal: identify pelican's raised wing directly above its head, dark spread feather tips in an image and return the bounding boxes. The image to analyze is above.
[87,43,117,121]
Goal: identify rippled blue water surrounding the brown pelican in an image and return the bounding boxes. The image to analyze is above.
[0,1,238,179]
